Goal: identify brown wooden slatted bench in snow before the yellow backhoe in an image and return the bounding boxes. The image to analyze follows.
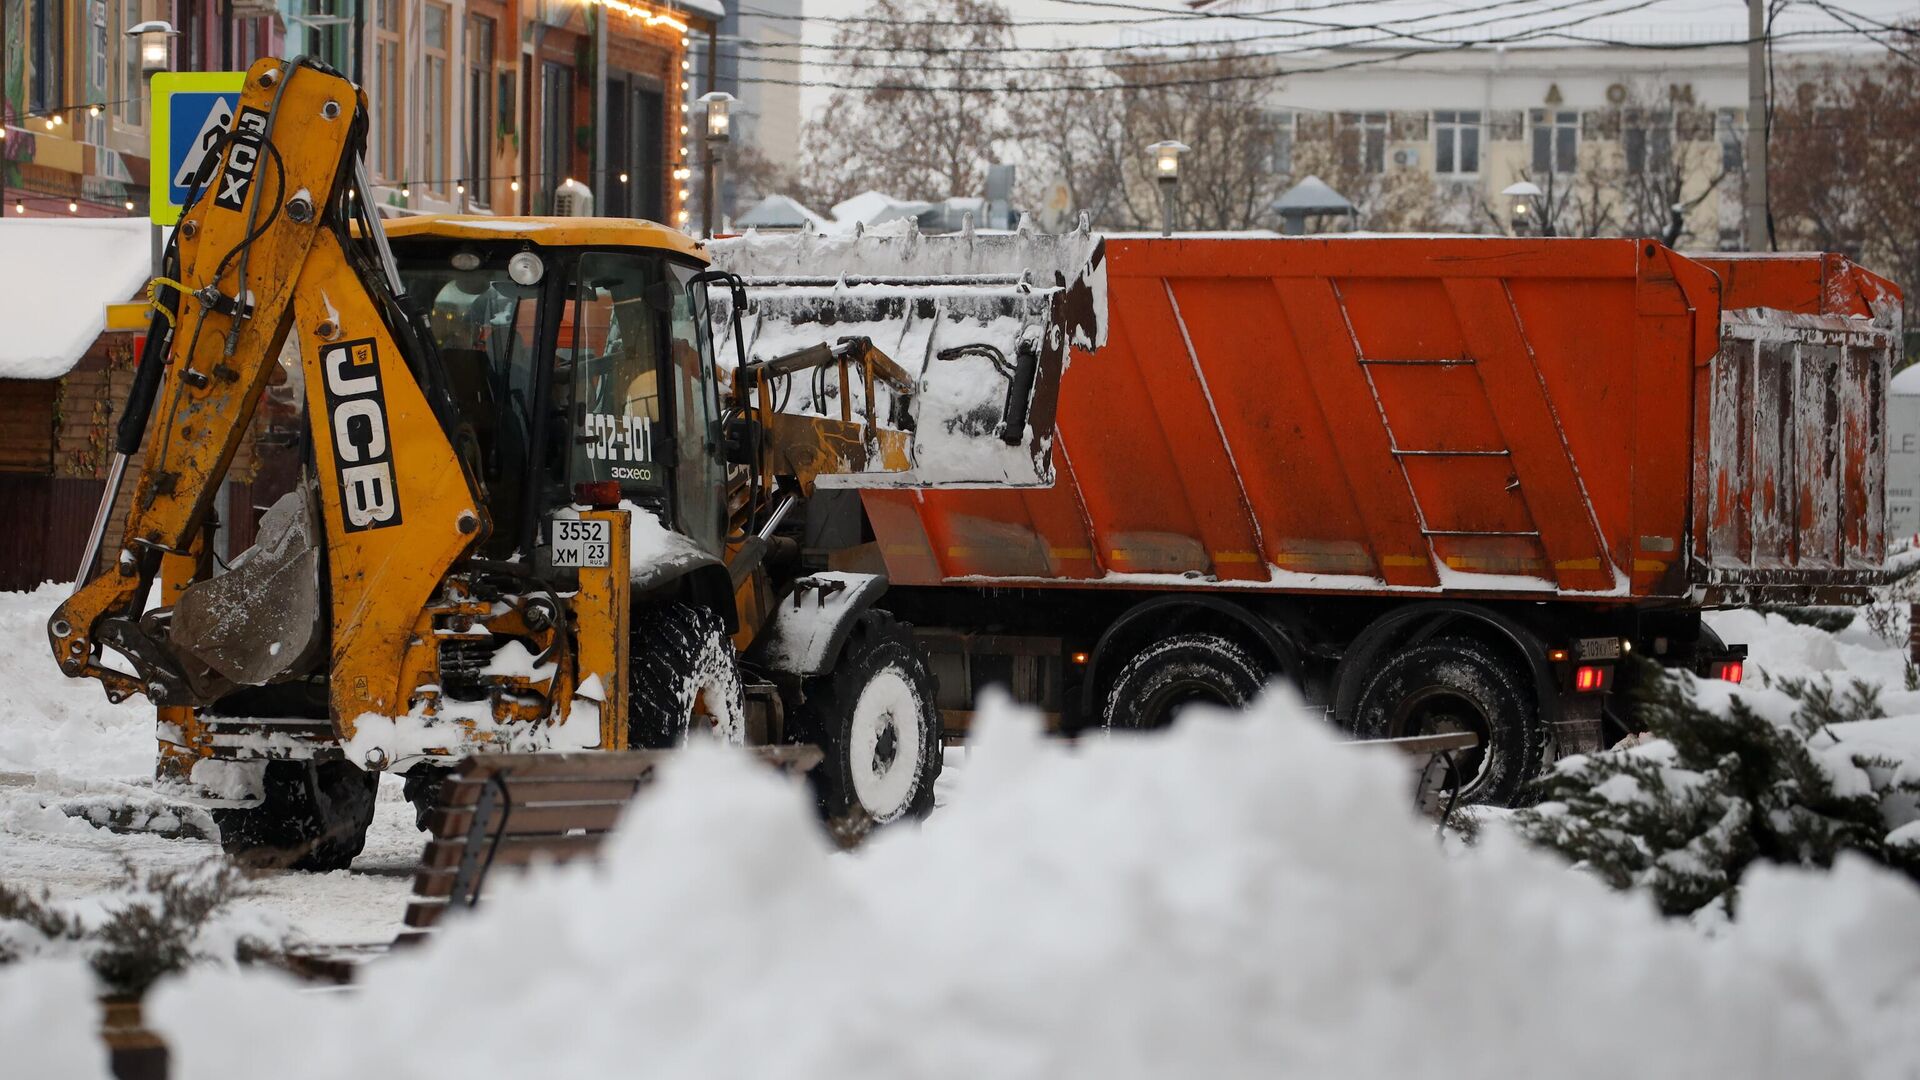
[396,746,822,944]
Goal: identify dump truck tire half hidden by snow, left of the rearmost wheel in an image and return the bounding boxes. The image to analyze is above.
[1100,630,1267,730]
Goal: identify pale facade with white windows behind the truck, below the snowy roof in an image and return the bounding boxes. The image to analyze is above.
[1271,48,1747,248]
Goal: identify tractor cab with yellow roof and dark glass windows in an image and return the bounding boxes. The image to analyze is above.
[386,217,726,565]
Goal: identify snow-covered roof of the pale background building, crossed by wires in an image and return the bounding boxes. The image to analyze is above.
[1137,0,1912,50]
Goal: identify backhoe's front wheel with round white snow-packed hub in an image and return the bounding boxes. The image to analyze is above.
[797,611,947,826]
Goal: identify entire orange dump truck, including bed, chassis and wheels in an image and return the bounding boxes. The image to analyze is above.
[837,238,1901,801]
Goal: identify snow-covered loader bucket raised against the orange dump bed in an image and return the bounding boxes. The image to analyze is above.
[710,220,1106,488]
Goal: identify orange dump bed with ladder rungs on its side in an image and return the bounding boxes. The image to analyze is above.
[862,238,1891,601]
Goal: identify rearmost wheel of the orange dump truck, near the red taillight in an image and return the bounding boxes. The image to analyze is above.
[1350,638,1540,807]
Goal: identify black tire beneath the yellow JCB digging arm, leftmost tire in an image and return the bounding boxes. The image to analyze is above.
[213,761,380,872]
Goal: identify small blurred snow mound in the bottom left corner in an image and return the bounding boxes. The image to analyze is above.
[0,961,111,1080]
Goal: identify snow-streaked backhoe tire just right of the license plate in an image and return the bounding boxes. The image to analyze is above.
[626,603,747,749]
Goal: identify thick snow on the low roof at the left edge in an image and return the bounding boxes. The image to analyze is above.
[0,217,152,379]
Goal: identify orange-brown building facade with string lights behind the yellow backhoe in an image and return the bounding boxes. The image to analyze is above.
[0,0,724,225]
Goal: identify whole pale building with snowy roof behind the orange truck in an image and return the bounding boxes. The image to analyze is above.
[1159,0,1912,237]
